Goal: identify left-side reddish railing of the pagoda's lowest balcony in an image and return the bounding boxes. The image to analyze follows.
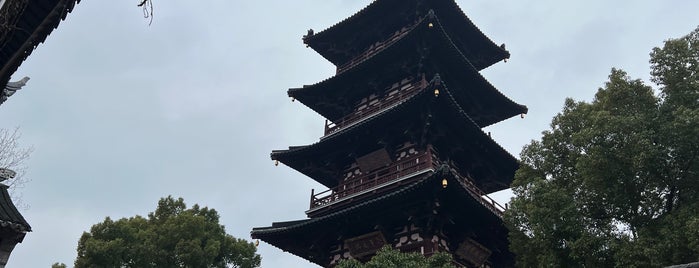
[311,151,437,210]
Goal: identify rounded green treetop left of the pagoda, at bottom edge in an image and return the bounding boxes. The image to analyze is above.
[75,196,261,268]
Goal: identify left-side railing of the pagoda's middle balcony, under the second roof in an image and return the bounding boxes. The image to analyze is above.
[321,77,427,139]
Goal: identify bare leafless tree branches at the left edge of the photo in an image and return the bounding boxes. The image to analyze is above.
[0,128,33,209]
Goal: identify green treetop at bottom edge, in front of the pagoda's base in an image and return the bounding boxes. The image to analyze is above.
[336,246,454,268]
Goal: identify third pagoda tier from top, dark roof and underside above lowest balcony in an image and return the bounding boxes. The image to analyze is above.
[271,78,518,198]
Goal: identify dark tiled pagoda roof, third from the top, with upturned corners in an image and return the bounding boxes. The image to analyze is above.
[271,78,518,193]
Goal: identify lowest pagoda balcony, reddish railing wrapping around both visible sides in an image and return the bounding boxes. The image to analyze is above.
[306,146,506,217]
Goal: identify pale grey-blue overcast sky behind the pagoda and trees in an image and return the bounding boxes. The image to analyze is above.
[0,0,699,267]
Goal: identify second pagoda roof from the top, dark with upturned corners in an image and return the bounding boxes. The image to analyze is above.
[288,15,527,127]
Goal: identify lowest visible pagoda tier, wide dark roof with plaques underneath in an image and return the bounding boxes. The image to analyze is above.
[251,167,514,267]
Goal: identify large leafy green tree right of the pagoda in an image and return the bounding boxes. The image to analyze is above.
[505,28,699,267]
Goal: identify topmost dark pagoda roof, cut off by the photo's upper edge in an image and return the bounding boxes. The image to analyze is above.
[303,0,510,71]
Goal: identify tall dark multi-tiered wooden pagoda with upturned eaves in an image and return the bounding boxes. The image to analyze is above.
[251,0,527,267]
